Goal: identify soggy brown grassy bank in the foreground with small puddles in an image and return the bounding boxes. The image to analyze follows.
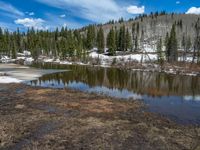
[0,84,200,150]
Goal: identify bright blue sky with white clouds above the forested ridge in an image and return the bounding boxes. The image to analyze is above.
[0,0,200,31]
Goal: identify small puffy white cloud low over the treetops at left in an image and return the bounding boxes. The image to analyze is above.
[14,18,47,30]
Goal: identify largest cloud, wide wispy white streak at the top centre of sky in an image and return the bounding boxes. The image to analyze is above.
[37,0,129,22]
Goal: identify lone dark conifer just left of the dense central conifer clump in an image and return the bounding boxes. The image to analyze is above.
[97,27,104,53]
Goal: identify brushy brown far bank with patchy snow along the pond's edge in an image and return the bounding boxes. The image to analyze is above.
[34,61,200,76]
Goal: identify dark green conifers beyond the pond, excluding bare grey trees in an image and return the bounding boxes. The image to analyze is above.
[0,12,200,63]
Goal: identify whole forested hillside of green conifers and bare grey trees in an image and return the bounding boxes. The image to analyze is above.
[0,12,200,62]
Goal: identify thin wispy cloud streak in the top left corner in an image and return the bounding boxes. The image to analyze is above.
[0,1,24,16]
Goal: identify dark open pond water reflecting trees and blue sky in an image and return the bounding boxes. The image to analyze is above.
[28,63,200,124]
